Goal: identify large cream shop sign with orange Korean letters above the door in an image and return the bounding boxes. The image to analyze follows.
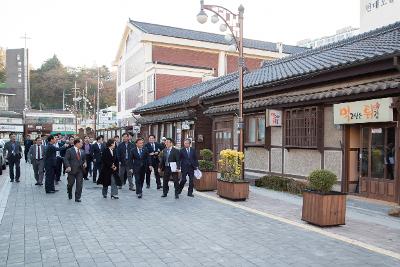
[333,97,393,124]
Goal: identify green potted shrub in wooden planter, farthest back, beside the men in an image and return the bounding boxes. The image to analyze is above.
[194,149,217,191]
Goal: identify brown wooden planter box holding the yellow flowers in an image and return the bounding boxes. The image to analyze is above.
[217,180,249,200]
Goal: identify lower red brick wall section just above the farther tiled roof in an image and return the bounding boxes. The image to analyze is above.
[155,74,202,99]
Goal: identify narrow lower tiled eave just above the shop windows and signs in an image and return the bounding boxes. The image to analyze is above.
[204,77,400,115]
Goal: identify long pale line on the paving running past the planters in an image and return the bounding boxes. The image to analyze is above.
[196,191,400,260]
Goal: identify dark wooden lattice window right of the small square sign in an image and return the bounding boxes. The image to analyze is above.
[284,107,323,148]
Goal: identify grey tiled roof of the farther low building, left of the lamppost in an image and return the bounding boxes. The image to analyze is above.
[134,72,238,113]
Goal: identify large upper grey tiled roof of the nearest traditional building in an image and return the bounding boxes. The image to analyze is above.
[201,21,400,99]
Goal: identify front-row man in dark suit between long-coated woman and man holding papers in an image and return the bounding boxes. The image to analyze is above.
[129,138,153,198]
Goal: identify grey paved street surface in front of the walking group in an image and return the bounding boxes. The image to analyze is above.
[0,164,400,266]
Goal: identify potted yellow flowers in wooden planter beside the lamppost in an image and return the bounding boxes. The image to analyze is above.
[217,149,249,200]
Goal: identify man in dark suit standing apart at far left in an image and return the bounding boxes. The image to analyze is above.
[3,133,22,183]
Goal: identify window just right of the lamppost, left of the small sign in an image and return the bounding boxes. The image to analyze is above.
[246,114,265,145]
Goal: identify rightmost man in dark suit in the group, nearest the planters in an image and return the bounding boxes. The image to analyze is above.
[179,139,199,197]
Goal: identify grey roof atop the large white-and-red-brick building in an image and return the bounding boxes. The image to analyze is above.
[129,19,308,54]
